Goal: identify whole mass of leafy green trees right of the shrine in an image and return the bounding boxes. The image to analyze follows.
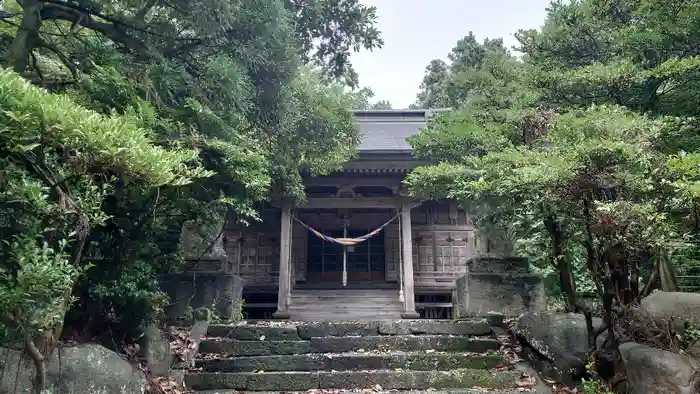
[407,0,700,390]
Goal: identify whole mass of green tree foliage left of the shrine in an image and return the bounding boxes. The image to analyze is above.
[0,0,382,364]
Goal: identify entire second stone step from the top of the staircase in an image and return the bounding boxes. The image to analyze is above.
[199,335,500,356]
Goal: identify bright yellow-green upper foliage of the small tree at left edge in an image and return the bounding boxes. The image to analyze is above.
[0,70,208,186]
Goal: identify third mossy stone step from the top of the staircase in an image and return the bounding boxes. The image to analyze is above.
[196,351,503,372]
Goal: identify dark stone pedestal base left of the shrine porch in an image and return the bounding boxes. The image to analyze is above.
[161,272,245,321]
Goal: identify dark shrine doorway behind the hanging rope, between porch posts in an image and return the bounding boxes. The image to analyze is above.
[307,229,386,284]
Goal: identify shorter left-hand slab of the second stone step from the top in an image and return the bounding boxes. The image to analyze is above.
[199,339,310,356]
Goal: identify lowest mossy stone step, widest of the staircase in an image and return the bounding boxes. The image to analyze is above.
[185,369,521,392]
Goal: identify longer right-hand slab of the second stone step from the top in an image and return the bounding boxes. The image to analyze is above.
[310,335,500,353]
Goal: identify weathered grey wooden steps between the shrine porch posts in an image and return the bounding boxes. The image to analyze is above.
[289,289,403,321]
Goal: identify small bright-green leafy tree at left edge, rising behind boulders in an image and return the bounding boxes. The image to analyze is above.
[0,71,209,392]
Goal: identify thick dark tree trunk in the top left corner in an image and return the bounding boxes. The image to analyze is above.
[6,0,41,73]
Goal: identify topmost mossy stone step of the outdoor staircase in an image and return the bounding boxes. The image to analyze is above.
[207,319,492,341]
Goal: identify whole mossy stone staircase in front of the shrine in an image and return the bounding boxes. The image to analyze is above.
[185,320,528,394]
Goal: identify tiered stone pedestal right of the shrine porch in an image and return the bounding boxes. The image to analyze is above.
[455,257,546,318]
